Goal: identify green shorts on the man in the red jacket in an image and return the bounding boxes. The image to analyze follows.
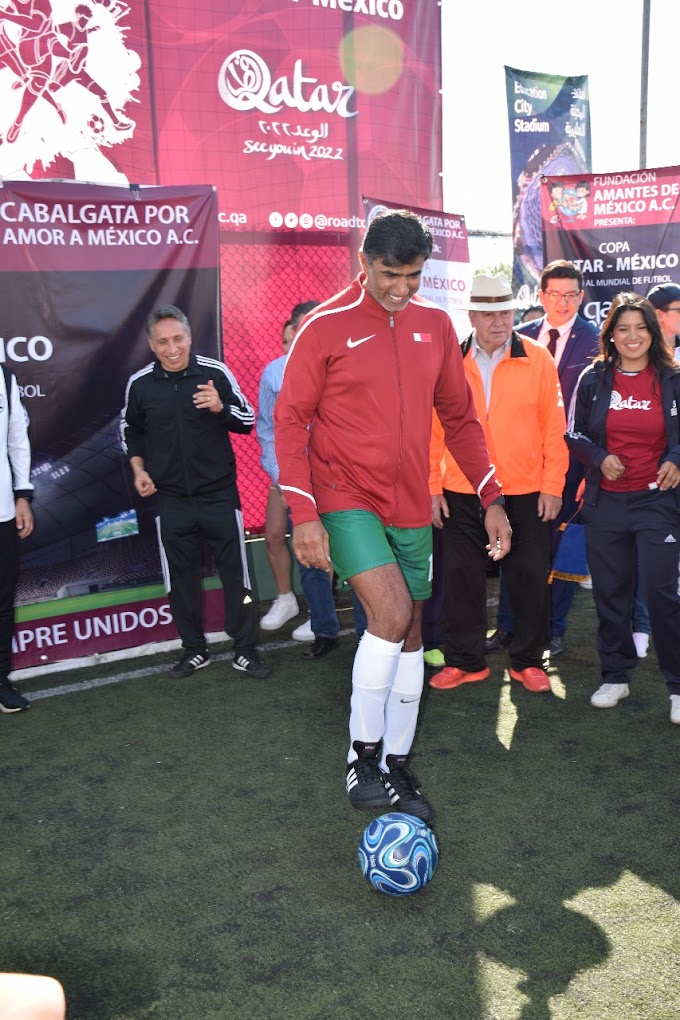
[321,510,432,602]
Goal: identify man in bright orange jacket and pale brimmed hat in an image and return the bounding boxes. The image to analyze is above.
[429,273,569,692]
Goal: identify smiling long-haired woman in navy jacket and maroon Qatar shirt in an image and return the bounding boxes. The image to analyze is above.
[567,294,680,724]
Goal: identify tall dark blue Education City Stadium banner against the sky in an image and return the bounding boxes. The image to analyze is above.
[506,67,591,308]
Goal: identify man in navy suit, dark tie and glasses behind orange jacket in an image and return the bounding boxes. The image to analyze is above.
[486,259,598,656]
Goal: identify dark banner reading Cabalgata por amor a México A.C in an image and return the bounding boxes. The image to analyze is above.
[0,181,221,668]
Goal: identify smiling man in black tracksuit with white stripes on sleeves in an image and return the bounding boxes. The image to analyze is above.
[120,305,269,678]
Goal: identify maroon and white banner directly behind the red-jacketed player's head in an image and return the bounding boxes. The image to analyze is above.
[364,198,472,339]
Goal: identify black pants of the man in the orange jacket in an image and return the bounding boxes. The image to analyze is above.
[442,490,551,672]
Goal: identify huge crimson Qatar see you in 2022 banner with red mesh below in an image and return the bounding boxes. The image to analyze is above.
[0,0,441,529]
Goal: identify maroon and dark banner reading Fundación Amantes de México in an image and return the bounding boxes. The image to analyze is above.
[541,166,680,326]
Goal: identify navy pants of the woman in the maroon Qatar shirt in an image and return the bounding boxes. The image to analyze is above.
[581,490,680,695]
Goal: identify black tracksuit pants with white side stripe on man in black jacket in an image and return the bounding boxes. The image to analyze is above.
[158,490,259,656]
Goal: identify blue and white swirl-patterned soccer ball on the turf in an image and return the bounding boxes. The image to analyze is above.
[359,811,439,896]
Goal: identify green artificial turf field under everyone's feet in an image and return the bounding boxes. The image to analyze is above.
[0,591,680,1020]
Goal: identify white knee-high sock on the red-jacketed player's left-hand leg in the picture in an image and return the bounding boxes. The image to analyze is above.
[347,630,404,763]
